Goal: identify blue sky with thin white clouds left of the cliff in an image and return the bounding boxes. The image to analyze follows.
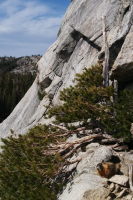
[0,0,70,57]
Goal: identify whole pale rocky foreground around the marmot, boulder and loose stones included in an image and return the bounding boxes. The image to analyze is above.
[58,143,132,200]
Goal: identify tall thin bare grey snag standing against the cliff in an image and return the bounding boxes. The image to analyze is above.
[102,16,109,87]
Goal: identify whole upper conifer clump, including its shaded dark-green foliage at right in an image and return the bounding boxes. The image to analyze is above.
[48,64,133,140]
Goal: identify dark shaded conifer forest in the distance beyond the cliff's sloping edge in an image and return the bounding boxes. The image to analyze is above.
[0,72,35,122]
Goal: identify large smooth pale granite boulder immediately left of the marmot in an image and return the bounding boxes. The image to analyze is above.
[58,143,113,200]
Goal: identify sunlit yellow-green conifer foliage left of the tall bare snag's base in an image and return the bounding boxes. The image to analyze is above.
[49,65,113,126]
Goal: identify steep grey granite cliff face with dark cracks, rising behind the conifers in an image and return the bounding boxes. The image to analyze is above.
[0,0,133,137]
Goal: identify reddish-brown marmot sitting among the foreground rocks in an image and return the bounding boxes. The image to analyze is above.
[96,162,121,178]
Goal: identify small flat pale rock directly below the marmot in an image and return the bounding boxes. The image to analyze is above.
[109,175,129,186]
